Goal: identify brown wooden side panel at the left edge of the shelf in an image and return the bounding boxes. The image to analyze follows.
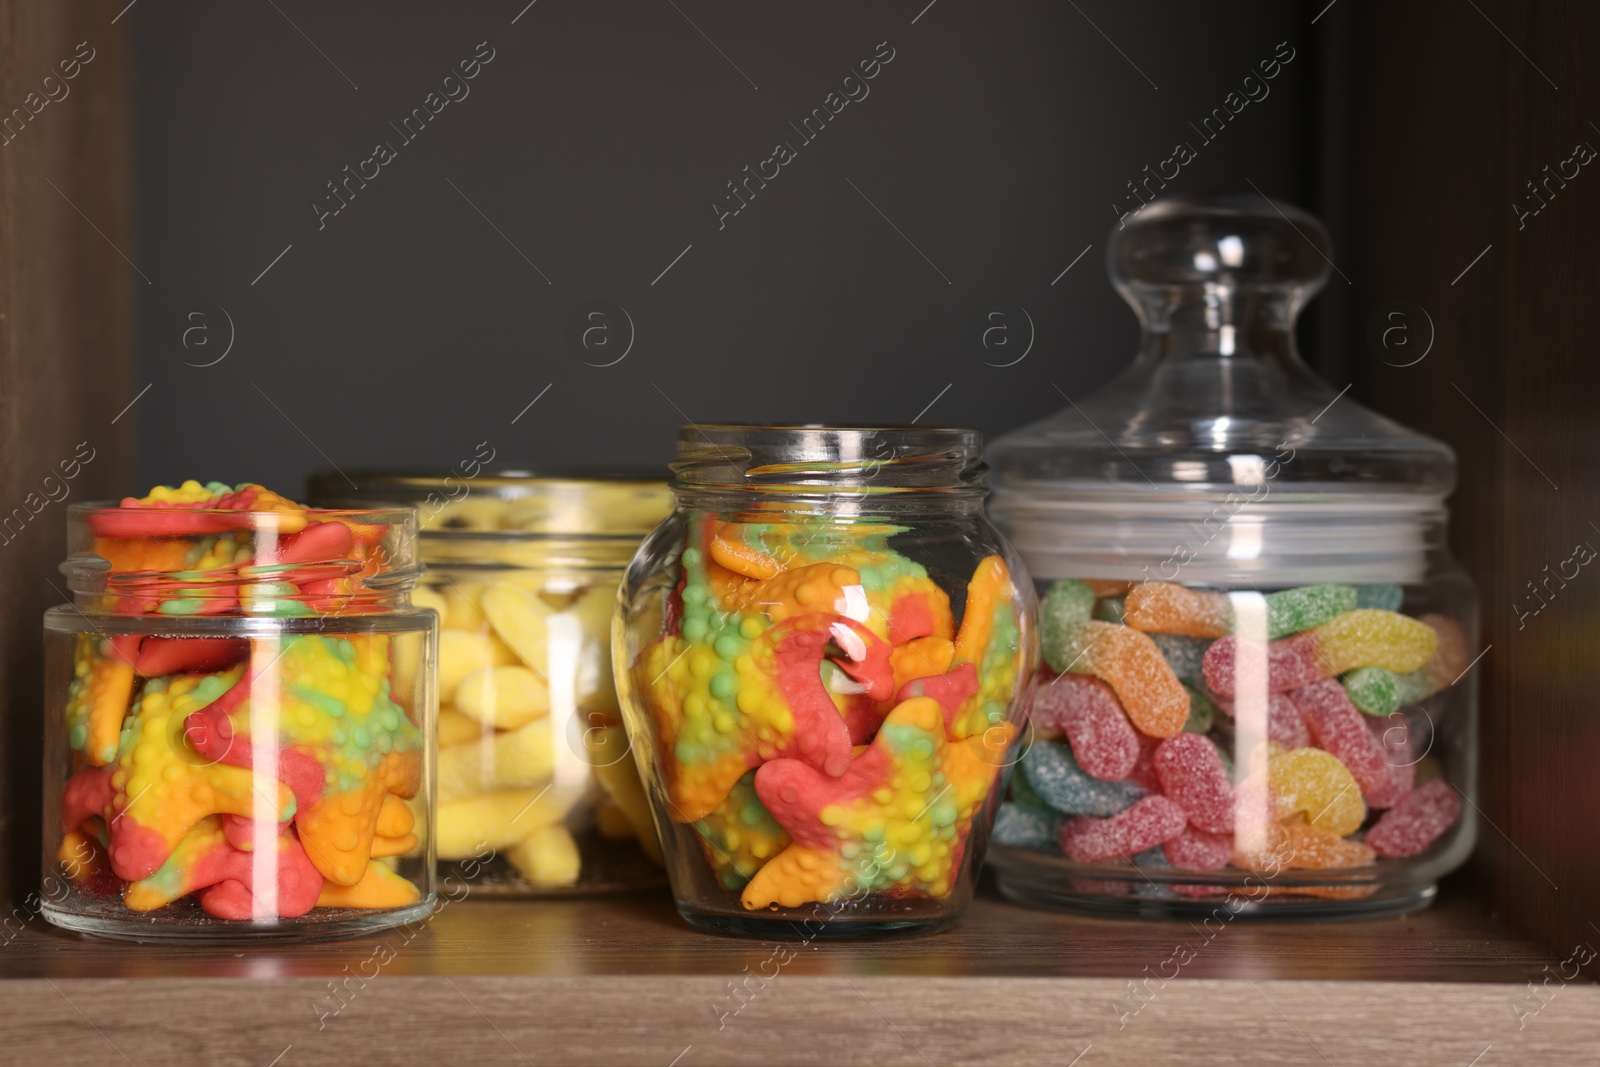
[0,0,130,899]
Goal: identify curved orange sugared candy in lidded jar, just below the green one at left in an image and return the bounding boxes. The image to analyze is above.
[1051,622,1189,737]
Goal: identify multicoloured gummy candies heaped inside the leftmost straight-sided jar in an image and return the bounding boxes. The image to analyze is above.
[59,482,426,920]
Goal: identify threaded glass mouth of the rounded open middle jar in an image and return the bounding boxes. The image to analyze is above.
[670,422,986,499]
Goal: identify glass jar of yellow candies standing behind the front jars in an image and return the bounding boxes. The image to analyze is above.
[310,470,672,897]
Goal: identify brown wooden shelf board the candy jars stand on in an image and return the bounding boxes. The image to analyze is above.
[0,888,1600,1067]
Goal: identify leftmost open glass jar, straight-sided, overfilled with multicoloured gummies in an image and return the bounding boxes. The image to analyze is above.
[42,483,435,941]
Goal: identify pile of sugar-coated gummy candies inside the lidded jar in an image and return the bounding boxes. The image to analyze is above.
[995,579,1470,899]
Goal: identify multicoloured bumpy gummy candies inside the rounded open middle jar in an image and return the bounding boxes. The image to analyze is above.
[634,514,1017,910]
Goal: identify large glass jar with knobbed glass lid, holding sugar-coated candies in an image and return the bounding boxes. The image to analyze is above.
[990,197,1478,917]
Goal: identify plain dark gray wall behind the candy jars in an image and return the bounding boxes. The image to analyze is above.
[126,0,1326,493]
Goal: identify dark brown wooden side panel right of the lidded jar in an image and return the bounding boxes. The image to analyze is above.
[1330,0,1600,973]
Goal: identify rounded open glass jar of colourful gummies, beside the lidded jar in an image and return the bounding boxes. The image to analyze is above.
[613,426,1035,941]
